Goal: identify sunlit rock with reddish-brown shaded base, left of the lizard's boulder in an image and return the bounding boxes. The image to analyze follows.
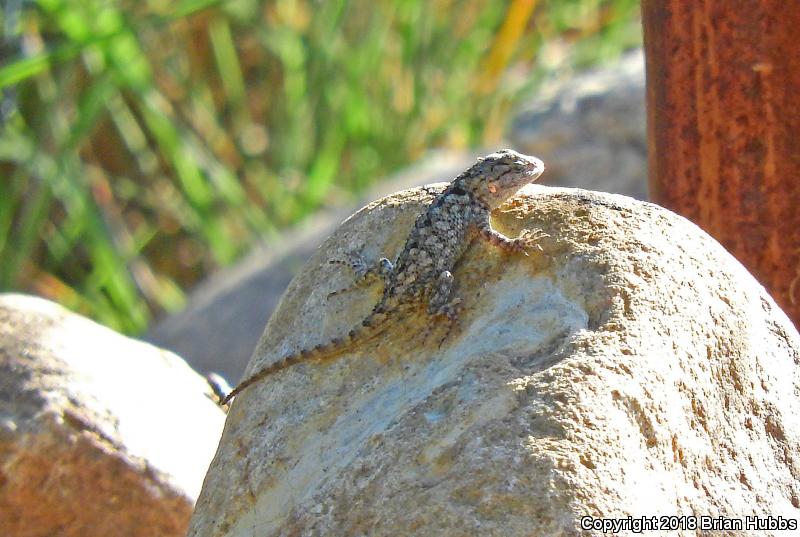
[0,294,224,537]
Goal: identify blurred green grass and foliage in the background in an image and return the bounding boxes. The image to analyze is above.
[0,0,640,333]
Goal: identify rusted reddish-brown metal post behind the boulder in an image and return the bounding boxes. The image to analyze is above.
[642,0,800,326]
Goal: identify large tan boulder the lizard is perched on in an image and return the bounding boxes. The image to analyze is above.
[189,186,800,537]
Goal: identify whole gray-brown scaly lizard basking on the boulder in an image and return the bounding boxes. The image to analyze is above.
[221,149,544,405]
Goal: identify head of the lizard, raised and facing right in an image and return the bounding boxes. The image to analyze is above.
[455,149,544,209]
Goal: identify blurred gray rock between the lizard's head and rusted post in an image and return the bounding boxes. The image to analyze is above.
[509,50,647,199]
